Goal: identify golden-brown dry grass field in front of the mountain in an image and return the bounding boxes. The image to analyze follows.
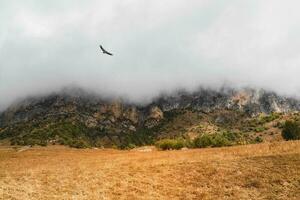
[0,141,300,200]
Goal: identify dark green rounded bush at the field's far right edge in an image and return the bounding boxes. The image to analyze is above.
[281,121,300,140]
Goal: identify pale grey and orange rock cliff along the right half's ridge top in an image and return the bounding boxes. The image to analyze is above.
[154,89,300,115]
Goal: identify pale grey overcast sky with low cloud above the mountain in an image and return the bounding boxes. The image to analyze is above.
[0,0,300,109]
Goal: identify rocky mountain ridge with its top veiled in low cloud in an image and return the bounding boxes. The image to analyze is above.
[0,88,300,148]
